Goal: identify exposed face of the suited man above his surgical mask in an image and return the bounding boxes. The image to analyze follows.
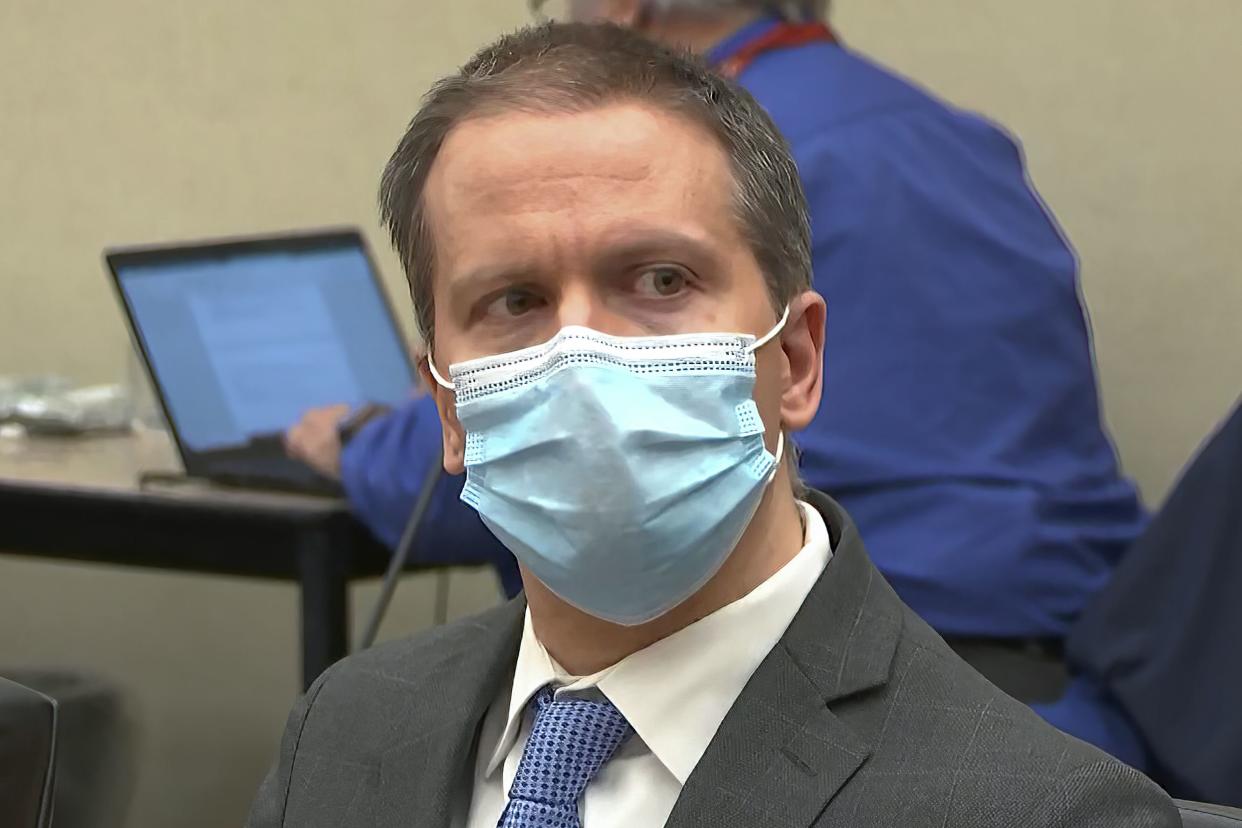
[425,104,789,472]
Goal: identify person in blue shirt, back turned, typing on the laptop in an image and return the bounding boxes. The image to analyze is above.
[289,0,1146,768]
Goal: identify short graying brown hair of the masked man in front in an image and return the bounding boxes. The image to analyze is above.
[380,24,811,346]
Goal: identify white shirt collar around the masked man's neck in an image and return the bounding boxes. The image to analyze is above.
[487,503,832,785]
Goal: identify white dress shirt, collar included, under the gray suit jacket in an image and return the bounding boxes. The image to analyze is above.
[466,503,832,828]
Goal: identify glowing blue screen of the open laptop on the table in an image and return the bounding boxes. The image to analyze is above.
[117,243,411,451]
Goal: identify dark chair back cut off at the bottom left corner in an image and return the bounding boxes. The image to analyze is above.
[0,678,56,828]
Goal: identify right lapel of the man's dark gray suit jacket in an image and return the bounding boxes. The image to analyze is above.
[666,493,902,828]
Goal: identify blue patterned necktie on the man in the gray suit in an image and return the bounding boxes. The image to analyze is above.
[497,688,632,828]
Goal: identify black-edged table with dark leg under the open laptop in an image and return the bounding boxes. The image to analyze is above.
[0,433,414,686]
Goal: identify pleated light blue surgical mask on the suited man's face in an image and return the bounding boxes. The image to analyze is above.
[432,309,789,624]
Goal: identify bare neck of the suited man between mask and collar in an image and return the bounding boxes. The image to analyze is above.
[522,466,804,675]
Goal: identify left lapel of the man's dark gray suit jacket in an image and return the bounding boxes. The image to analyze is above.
[374,600,525,828]
